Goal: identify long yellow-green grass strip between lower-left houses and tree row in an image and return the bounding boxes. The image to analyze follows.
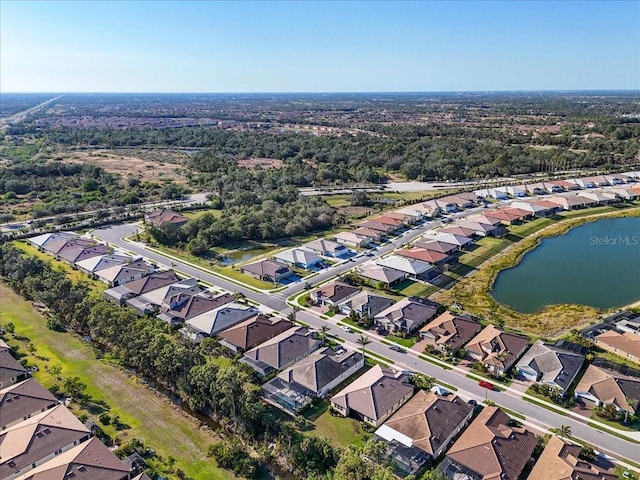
[0,284,235,480]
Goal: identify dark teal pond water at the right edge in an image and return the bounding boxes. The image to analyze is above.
[491,217,640,313]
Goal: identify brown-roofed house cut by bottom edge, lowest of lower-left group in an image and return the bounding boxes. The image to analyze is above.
[15,437,132,480]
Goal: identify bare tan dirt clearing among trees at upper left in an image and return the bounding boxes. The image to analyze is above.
[62,150,188,184]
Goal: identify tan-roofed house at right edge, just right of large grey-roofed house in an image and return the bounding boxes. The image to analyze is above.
[575,365,640,415]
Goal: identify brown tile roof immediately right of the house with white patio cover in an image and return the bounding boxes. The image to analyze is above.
[447,407,537,480]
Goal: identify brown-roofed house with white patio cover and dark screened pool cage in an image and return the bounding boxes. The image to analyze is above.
[375,390,473,475]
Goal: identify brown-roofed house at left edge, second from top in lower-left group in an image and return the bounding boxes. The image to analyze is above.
[0,378,58,430]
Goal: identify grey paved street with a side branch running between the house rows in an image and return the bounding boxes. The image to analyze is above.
[93,219,640,462]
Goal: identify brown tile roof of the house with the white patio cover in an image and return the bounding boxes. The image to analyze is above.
[385,390,473,456]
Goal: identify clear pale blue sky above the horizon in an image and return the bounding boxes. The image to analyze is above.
[0,0,640,92]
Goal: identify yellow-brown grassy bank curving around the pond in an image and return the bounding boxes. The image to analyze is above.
[433,204,640,337]
